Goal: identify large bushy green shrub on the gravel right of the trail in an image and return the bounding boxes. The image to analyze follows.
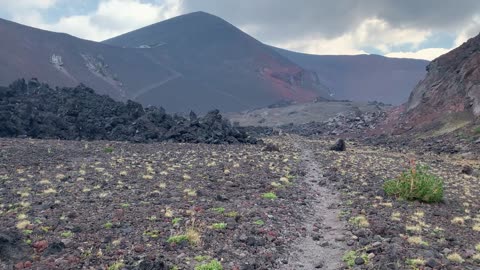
[383,166,443,203]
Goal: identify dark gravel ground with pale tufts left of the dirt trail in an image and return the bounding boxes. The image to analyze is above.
[0,139,305,269]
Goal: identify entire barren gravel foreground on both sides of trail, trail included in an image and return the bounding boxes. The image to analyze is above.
[0,136,480,269]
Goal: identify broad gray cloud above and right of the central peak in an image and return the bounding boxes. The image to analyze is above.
[182,0,480,42]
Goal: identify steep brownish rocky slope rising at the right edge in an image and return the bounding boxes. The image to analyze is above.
[403,31,480,129]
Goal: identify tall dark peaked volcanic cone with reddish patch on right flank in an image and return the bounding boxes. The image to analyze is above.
[104,12,327,111]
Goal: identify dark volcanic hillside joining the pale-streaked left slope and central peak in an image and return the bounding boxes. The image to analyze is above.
[0,13,328,112]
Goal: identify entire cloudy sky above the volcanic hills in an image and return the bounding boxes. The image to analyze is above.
[0,0,480,60]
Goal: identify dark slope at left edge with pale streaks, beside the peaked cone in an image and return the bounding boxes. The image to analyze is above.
[0,19,174,103]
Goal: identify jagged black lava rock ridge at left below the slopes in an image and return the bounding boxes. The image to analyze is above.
[0,79,256,144]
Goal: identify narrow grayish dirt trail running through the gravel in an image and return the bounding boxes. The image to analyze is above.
[279,140,347,270]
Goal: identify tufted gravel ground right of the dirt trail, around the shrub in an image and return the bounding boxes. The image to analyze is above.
[307,139,480,269]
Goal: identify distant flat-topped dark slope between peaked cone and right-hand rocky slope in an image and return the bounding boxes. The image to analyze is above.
[275,48,428,104]
